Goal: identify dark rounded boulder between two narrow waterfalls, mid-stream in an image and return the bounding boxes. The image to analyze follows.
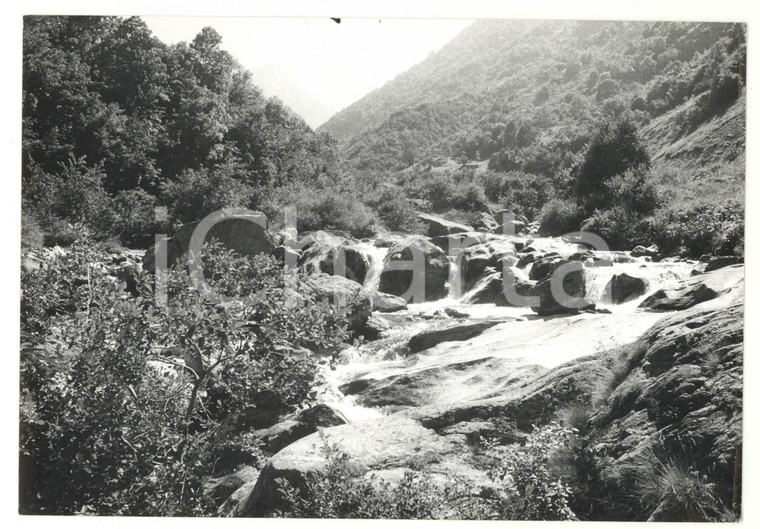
[379,237,449,302]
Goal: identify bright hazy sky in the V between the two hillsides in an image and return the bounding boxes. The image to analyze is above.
[142,16,472,127]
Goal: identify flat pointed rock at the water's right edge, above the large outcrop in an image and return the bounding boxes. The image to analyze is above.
[639,265,744,310]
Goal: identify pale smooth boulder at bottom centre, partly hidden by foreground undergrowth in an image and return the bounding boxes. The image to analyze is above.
[233,416,492,517]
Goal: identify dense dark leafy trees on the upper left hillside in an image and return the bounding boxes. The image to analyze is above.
[23,17,346,246]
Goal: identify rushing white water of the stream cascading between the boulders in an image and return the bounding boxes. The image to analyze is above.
[308,231,712,421]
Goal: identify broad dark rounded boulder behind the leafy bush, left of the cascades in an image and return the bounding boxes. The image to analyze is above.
[143,210,275,272]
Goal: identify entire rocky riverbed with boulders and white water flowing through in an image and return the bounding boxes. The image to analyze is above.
[126,208,744,520]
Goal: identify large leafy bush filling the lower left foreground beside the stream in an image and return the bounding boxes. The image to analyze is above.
[20,243,346,515]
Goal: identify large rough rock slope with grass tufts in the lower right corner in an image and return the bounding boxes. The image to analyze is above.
[585,301,744,521]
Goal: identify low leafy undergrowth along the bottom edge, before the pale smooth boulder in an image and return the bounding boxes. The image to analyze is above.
[278,422,576,520]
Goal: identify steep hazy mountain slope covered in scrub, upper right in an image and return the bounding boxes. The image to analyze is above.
[319,20,746,196]
